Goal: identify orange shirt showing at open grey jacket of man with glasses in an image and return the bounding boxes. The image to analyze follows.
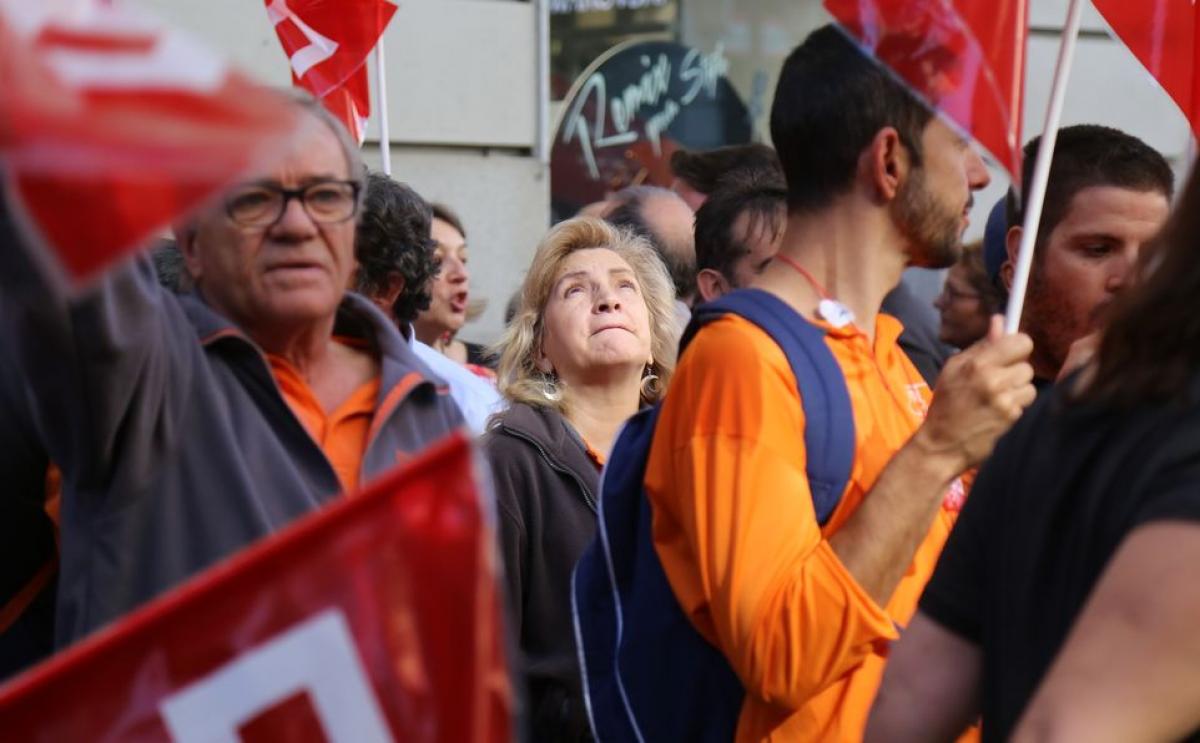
[266,354,379,493]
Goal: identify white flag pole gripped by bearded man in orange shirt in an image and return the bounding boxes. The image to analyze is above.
[1004,0,1084,334]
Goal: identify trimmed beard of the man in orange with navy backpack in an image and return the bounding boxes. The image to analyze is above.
[892,168,962,269]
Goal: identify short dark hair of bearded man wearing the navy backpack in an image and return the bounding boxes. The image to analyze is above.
[770,25,932,212]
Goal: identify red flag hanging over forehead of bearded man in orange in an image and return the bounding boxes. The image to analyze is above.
[824,0,1028,182]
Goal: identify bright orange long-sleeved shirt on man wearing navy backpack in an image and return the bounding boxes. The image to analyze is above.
[646,314,961,743]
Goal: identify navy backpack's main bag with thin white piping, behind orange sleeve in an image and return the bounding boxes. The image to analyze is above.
[571,406,745,743]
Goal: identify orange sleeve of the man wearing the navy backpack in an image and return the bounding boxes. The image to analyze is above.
[646,318,896,708]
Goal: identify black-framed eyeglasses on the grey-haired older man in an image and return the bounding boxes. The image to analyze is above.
[226,180,359,228]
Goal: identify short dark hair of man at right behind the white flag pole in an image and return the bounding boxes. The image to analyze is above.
[1006,124,1175,258]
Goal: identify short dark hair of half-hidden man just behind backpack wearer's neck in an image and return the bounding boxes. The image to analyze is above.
[696,167,787,281]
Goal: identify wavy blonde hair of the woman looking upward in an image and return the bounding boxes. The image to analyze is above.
[496,217,680,415]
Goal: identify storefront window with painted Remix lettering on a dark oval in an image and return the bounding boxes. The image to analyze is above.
[551,0,828,218]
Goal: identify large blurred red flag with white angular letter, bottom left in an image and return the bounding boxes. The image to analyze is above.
[0,436,511,743]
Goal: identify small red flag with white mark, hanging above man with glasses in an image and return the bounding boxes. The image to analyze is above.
[264,0,396,144]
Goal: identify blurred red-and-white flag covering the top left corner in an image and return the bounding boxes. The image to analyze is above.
[0,0,298,283]
